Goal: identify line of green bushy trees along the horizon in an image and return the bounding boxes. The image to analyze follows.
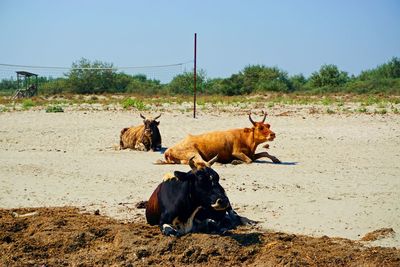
[0,57,400,96]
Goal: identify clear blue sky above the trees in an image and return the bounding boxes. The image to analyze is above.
[0,0,400,81]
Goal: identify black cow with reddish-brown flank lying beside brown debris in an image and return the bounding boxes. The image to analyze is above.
[146,156,250,236]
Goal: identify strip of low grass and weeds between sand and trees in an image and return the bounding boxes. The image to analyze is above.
[0,92,400,115]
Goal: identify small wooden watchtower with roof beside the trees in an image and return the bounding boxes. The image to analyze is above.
[13,71,38,99]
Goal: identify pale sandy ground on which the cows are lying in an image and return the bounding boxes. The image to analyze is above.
[0,107,400,248]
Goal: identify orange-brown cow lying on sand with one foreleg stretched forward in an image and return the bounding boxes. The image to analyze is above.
[158,113,280,164]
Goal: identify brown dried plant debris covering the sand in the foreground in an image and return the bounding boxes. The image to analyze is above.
[0,207,400,266]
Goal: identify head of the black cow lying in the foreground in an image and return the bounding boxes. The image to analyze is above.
[174,155,230,211]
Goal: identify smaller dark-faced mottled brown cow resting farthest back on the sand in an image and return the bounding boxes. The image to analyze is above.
[119,114,161,151]
